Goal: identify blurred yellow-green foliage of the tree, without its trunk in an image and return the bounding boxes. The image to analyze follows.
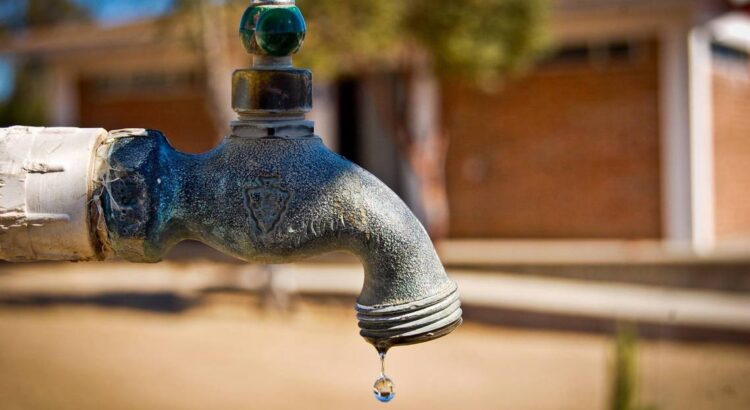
[297,0,548,80]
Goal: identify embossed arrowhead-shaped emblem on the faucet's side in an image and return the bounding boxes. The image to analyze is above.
[245,176,291,234]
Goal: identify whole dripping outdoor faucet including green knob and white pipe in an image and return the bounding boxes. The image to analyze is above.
[0,0,462,352]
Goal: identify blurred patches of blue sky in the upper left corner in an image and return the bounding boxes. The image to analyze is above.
[0,0,174,100]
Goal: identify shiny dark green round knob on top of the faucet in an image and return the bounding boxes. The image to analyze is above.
[240,0,307,57]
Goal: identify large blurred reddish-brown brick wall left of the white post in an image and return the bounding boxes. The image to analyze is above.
[443,43,661,238]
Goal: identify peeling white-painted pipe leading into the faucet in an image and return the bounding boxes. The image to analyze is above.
[0,127,108,262]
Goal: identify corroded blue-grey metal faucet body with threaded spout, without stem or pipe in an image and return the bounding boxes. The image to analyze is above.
[100,129,461,348]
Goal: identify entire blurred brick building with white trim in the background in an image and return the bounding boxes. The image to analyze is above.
[0,0,750,250]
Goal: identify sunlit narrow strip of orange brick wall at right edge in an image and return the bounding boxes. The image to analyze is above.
[713,66,750,239]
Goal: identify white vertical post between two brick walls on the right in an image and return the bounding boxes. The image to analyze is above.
[660,24,716,253]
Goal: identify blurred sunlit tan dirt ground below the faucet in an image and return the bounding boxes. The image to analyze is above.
[0,296,750,410]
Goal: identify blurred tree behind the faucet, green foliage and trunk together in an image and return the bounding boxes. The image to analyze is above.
[297,0,548,238]
